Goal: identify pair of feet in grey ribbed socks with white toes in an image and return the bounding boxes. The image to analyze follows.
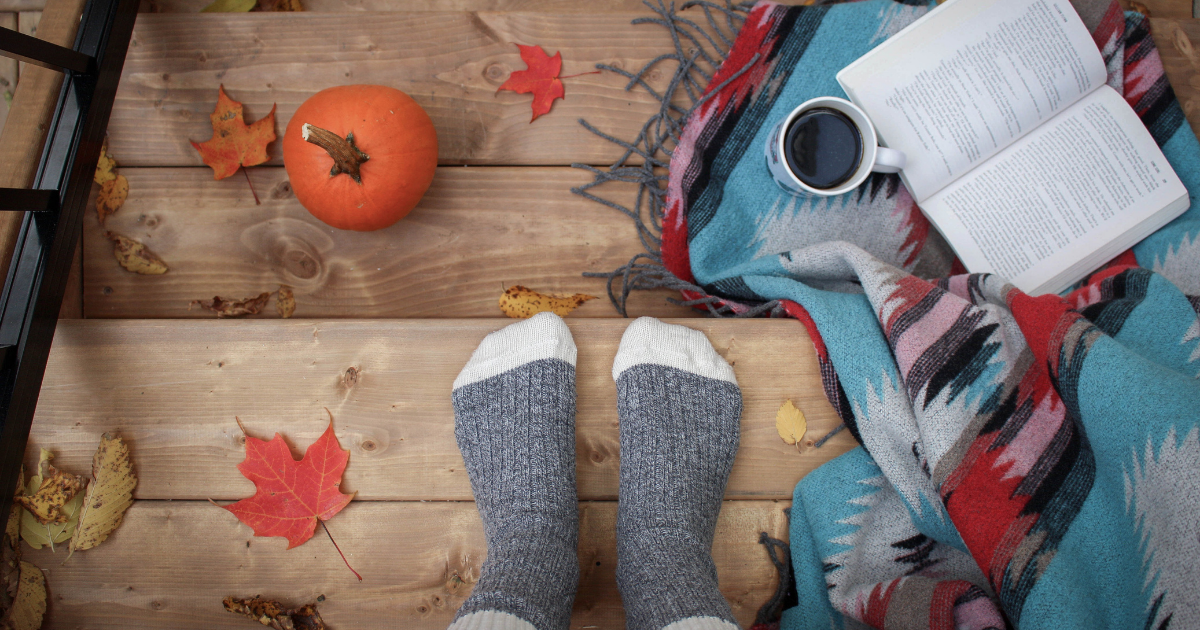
[450,313,742,630]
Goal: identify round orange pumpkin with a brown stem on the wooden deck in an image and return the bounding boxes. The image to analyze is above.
[283,85,438,232]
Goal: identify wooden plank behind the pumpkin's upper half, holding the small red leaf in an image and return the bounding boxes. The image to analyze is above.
[109,12,705,167]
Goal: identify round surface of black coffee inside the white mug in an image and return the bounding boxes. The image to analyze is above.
[784,107,863,188]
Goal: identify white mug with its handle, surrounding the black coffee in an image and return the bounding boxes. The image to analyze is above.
[766,96,905,197]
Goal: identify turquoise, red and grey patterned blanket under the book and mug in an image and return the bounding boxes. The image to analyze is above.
[626,0,1200,629]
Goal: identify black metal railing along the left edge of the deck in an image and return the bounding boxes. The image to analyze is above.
[0,0,138,518]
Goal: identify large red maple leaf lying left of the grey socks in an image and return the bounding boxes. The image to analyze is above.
[222,416,354,548]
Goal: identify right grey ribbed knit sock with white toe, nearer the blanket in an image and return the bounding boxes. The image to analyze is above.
[612,317,742,630]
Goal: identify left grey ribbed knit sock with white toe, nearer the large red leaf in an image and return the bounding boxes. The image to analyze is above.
[450,313,580,630]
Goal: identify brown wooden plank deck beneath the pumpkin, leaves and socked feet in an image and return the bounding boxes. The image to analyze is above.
[0,0,1200,629]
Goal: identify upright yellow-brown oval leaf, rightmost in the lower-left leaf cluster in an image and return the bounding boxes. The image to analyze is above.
[67,433,138,558]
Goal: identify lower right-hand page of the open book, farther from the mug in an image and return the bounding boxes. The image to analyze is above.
[922,86,1188,293]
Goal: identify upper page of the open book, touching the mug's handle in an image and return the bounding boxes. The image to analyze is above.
[838,0,1108,203]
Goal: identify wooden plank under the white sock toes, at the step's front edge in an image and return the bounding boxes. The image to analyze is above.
[26,318,854,500]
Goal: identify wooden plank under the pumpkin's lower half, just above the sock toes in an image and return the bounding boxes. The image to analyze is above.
[84,166,698,318]
